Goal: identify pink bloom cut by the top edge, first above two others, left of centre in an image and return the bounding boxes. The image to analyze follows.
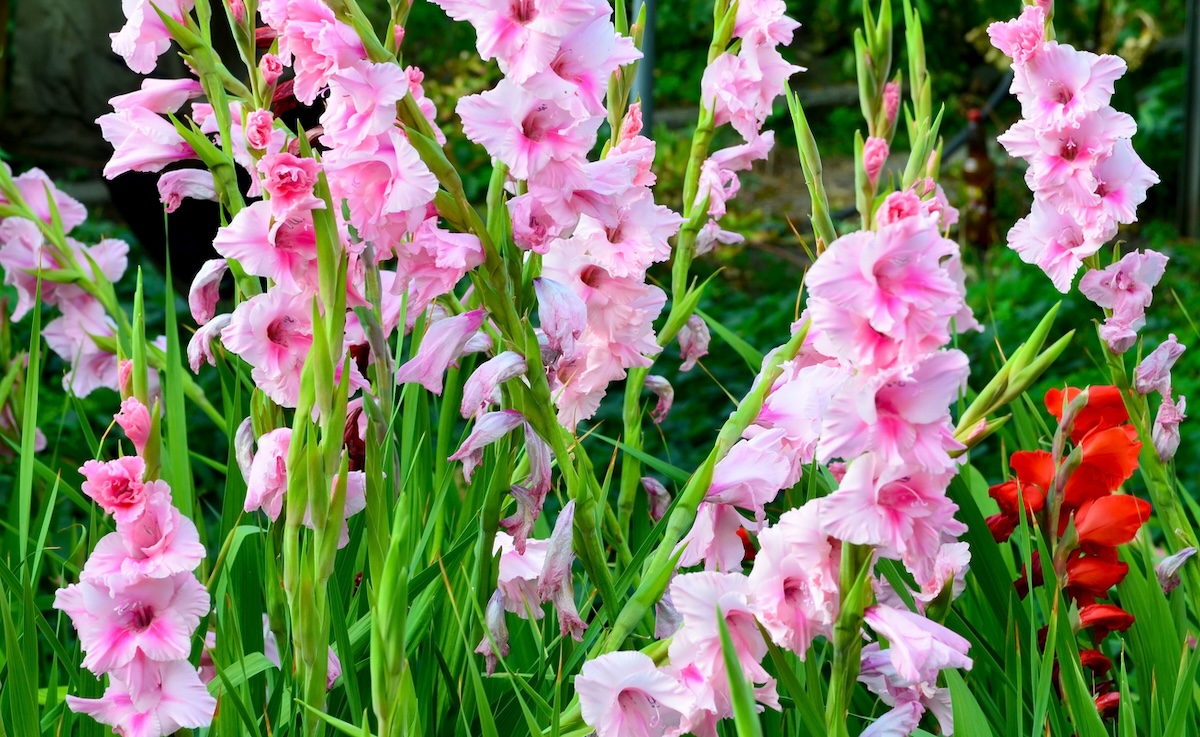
[269,0,367,104]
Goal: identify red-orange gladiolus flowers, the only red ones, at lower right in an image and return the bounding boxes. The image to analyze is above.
[988,387,1151,717]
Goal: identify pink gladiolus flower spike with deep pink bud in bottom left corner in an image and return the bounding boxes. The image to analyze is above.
[54,399,217,737]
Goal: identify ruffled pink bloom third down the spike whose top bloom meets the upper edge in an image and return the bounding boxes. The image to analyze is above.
[322,128,438,242]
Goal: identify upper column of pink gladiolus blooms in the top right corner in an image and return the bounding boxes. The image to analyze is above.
[988,5,1158,294]
